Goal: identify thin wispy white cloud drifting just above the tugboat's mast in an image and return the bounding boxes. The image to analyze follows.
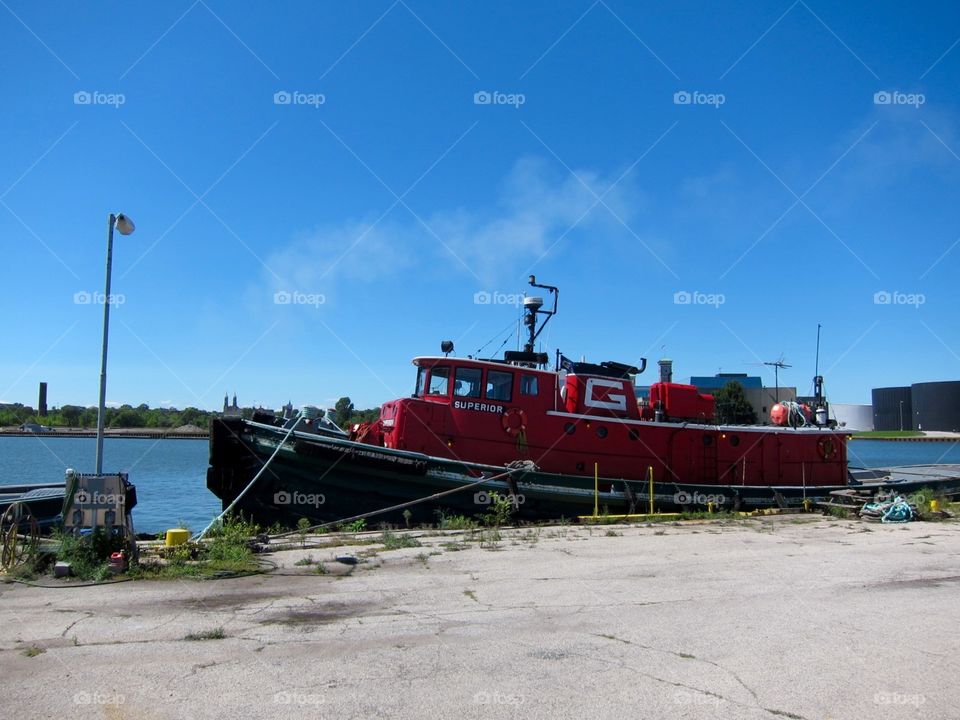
[258,158,642,296]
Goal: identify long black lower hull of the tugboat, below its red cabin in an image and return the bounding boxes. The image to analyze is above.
[207,419,960,527]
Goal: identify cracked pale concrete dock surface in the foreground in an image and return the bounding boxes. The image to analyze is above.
[0,516,960,720]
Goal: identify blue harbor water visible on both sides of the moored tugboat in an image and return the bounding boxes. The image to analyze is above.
[0,436,960,533]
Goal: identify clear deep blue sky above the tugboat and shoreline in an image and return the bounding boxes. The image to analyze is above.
[0,0,960,408]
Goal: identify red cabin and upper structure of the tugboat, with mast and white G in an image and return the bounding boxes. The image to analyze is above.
[350,276,847,486]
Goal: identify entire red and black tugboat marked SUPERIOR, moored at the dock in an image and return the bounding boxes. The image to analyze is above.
[207,276,944,525]
